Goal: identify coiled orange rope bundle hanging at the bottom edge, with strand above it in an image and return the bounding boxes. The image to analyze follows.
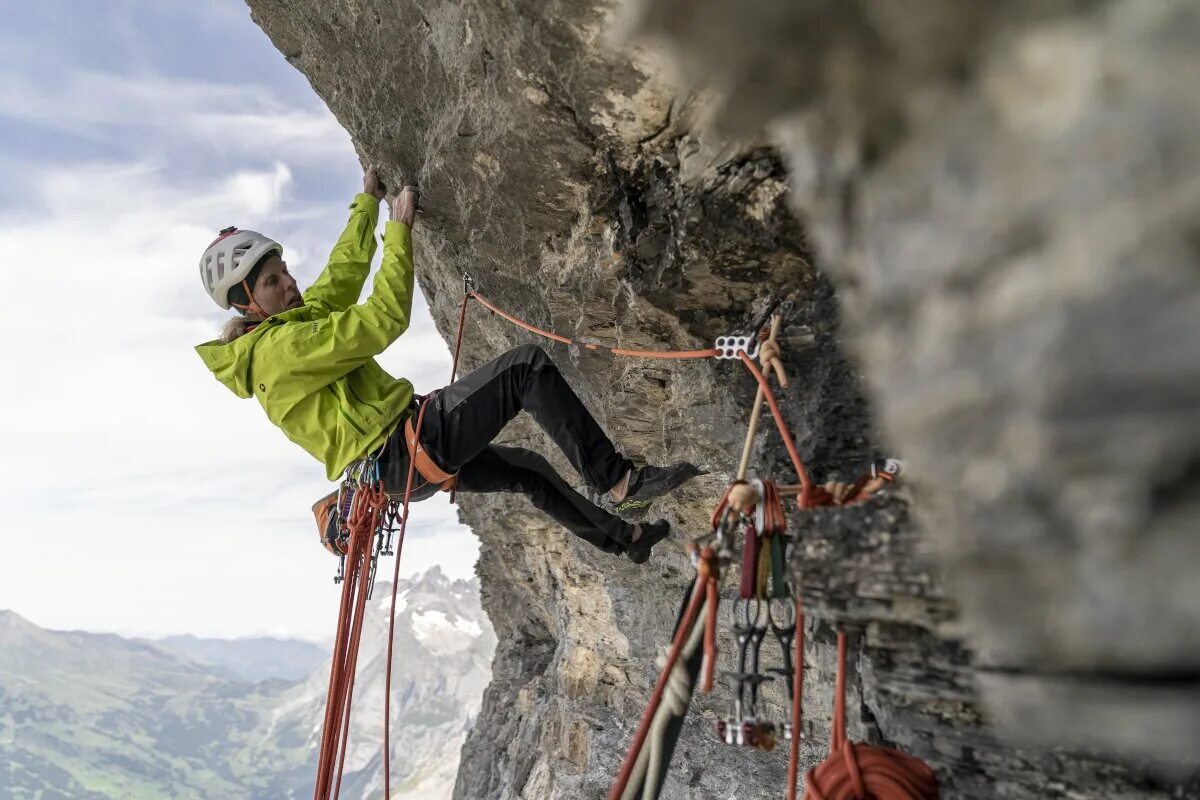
[804,631,938,800]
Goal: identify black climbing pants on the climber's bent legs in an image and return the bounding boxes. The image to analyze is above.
[379,344,632,553]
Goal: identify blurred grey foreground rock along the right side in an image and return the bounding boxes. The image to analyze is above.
[640,0,1200,758]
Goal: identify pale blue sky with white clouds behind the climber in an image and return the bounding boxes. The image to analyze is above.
[0,0,479,640]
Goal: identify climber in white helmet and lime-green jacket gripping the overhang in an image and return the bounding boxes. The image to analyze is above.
[197,169,700,564]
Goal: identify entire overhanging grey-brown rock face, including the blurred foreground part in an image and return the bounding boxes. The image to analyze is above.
[248,0,1200,800]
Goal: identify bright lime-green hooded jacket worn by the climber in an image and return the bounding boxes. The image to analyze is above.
[196,194,413,481]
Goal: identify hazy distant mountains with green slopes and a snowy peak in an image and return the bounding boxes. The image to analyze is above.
[0,569,496,800]
